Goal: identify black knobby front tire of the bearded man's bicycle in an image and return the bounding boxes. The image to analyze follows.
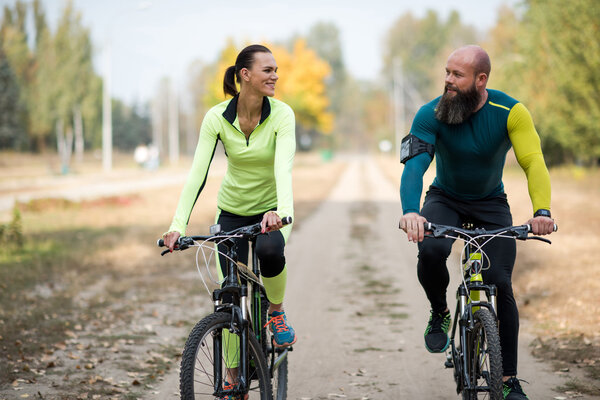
[462,308,503,400]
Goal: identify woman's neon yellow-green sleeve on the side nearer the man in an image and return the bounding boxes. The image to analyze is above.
[273,107,296,239]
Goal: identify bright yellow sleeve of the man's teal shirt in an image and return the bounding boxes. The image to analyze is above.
[507,103,550,212]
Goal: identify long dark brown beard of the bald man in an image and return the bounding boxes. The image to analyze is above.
[435,84,481,125]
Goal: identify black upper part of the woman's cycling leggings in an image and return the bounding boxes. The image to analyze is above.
[217,210,285,278]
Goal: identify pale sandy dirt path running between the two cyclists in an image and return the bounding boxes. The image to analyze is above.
[286,158,585,399]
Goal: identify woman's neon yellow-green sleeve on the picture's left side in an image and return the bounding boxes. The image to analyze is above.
[168,112,219,236]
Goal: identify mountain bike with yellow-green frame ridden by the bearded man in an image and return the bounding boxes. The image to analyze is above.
[425,222,557,400]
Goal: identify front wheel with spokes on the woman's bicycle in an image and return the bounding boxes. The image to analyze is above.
[179,312,272,400]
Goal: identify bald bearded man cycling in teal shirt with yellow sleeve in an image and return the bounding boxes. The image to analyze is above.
[400,45,554,400]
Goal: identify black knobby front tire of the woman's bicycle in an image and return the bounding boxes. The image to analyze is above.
[179,312,272,400]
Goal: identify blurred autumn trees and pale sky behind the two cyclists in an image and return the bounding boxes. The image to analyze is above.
[0,0,600,169]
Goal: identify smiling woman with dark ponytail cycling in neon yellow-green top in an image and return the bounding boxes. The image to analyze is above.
[164,45,296,396]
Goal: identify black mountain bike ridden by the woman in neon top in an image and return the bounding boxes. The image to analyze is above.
[157,217,293,400]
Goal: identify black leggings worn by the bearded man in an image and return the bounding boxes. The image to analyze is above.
[417,186,519,376]
